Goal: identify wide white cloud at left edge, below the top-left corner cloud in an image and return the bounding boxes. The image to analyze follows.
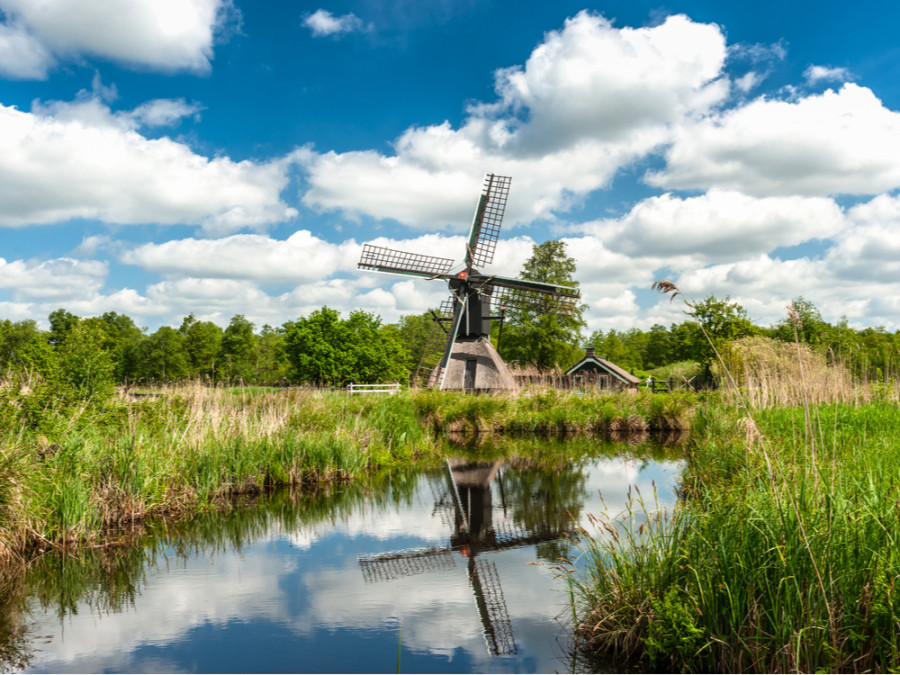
[0,99,296,232]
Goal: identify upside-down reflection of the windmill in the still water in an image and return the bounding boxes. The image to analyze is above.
[359,459,571,656]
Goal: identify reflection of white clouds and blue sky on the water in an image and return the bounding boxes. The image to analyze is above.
[24,459,681,672]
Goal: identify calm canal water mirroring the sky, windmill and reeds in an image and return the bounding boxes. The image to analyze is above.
[6,440,683,673]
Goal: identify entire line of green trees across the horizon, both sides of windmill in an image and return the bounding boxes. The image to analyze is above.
[0,241,900,394]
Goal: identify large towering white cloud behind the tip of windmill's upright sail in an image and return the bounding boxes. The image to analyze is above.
[302,12,728,230]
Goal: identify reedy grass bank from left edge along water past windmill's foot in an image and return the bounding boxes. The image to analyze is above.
[0,383,694,559]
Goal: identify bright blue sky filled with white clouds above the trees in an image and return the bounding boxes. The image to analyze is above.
[0,0,900,330]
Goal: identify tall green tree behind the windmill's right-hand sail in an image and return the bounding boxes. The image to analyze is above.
[495,240,587,370]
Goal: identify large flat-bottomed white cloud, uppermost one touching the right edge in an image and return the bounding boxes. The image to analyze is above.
[647,83,900,196]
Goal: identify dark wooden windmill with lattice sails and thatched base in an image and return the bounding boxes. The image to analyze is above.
[359,174,581,390]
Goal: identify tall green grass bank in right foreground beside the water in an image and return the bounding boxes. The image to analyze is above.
[571,402,900,672]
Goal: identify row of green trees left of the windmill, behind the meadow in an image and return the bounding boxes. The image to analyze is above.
[0,307,410,394]
